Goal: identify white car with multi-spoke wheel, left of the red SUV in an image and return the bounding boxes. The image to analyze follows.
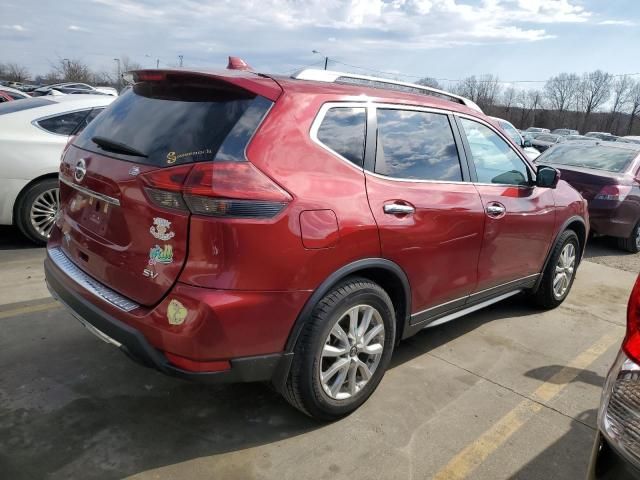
[0,95,115,244]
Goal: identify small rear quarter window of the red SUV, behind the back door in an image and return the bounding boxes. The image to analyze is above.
[318,107,367,167]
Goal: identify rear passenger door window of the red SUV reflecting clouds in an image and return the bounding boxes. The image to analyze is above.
[375,109,462,181]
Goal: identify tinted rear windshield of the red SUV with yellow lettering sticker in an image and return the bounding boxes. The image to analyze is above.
[74,82,271,166]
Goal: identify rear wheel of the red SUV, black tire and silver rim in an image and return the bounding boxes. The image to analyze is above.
[284,278,396,421]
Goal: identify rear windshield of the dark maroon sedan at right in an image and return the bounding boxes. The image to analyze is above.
[536,144,639,173]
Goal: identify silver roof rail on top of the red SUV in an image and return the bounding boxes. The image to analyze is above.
[291,68,484,113]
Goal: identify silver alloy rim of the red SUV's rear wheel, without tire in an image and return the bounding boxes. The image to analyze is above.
[319,305,385,400]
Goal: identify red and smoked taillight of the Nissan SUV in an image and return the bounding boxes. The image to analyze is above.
[140,162,292,218]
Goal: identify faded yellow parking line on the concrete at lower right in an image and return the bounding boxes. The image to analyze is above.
[433,334,620,480]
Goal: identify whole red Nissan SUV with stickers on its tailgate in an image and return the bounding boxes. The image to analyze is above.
[45,65,588,419]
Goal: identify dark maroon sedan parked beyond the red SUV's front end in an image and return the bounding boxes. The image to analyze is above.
[536,141,640,253]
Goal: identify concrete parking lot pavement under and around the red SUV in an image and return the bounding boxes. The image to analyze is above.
[0,228,638,479]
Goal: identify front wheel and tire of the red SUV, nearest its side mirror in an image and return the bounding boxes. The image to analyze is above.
[532,230,580,309]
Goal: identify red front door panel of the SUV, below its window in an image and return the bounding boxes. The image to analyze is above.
[476,184,556,290]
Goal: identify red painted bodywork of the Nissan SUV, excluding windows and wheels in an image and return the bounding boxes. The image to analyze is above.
[49,71,587,376]
